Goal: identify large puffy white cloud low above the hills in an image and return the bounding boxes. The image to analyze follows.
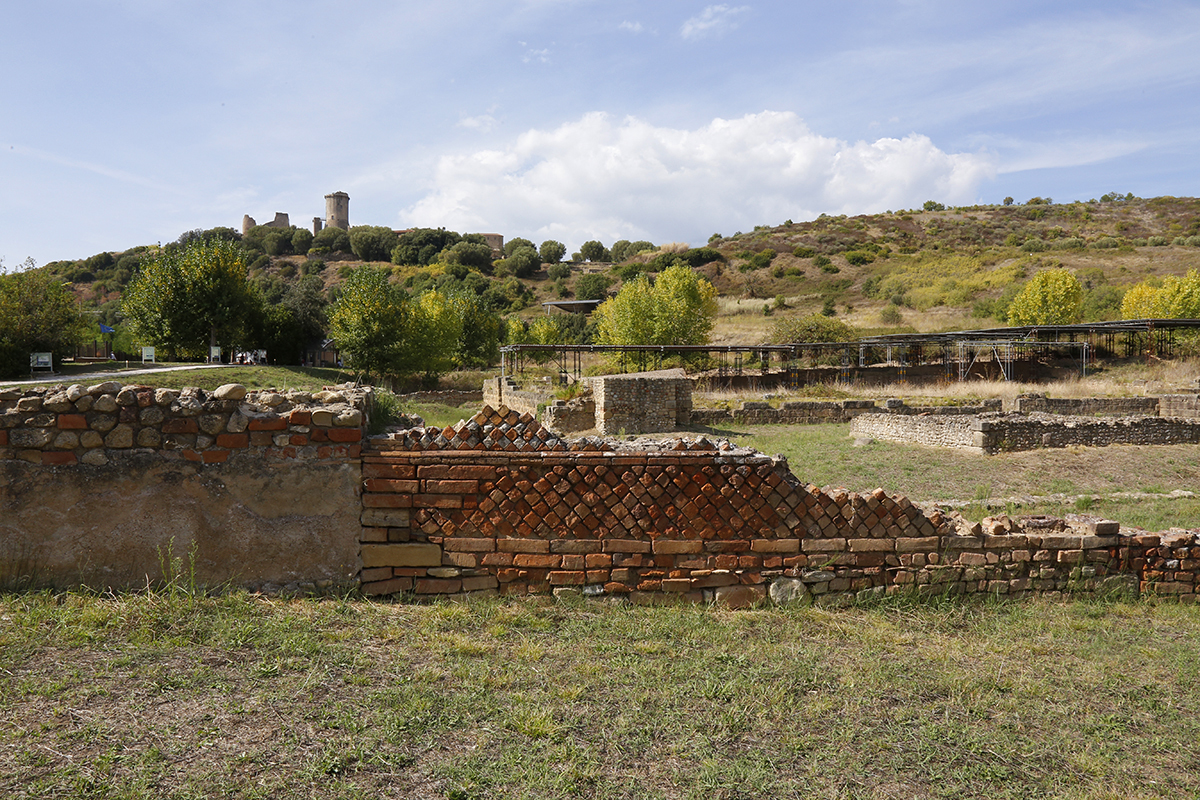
[401,112,996,247]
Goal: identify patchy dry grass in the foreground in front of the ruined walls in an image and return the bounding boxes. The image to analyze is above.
[7,590,1200,800]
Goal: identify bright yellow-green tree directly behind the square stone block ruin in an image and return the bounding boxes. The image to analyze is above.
[595,265,716,344]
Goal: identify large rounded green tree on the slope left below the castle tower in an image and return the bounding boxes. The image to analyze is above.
[121,240,262,357]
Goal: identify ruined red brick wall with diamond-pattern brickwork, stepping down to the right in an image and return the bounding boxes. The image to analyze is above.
[352,408,1200,606]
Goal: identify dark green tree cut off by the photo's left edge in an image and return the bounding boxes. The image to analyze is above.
[0,259,86,378]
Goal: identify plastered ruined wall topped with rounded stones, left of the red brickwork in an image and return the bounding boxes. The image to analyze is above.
[0,383,370,591]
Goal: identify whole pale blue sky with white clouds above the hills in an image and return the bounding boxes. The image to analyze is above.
[0,0,1200,269]
